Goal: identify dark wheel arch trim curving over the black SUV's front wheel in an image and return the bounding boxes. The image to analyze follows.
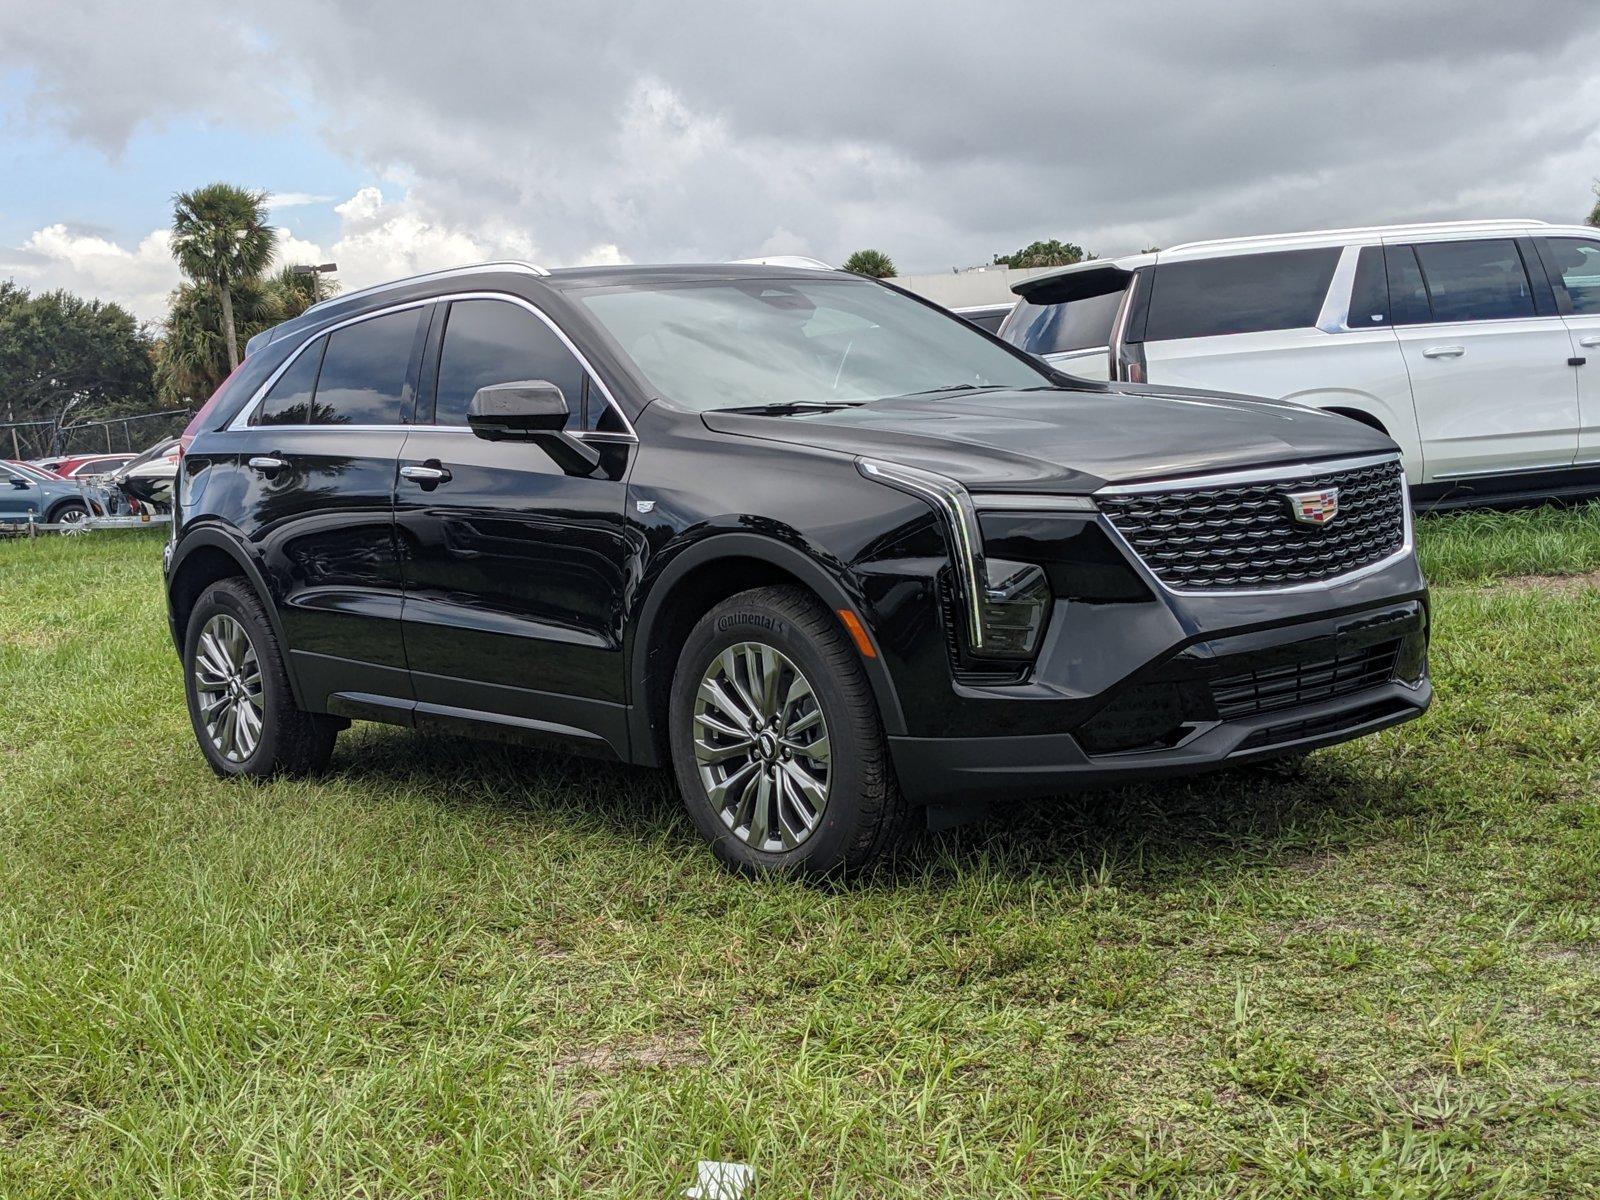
[627,533,904,766]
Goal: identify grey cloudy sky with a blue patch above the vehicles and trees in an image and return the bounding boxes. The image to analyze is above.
[0,0,1600,318]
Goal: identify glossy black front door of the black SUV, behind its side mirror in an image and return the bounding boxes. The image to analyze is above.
[395,298,635,752]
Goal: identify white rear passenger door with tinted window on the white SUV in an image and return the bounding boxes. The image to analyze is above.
[1386,237,1578,482]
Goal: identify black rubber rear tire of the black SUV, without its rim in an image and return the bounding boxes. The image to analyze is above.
[182,579,342,779]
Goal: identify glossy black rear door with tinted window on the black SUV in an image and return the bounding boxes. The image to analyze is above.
[234,302,430,710]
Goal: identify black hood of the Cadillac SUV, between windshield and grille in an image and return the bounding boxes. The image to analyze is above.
[702,384,1397,493]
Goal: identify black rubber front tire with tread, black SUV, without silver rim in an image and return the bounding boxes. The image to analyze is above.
[669,587,910,875]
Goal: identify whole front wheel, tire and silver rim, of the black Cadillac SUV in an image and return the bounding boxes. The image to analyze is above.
[669,587,907,875]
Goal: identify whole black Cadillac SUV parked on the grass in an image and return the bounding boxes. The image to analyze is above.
[166,262,1430,872]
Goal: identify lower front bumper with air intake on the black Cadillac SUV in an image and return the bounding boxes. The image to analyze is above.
[890,598,1432,803]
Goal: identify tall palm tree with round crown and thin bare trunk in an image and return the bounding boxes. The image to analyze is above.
[173,184,278,370]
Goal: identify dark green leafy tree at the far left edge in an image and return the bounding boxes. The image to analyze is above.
[0,282,154,421]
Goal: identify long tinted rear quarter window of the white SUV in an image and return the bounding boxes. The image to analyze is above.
[1144,246,1339,341]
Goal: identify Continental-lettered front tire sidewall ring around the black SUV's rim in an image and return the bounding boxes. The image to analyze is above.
[667,597,875,874]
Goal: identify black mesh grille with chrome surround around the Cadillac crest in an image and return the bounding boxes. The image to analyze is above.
[1096,459,1406,592]
